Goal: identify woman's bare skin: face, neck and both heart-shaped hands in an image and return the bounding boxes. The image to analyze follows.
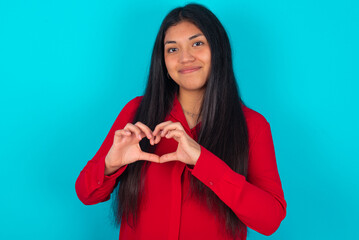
[105,21,211,175]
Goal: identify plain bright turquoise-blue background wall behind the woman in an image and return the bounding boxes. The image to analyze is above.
[0,0,359,240]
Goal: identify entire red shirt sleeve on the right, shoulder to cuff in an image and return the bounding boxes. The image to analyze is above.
[191,118,286,235]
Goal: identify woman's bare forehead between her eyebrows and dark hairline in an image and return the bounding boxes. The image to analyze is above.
[164,21,203,41]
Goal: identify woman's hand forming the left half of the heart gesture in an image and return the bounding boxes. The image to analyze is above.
[105,122,160,175]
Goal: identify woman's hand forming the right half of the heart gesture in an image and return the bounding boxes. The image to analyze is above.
[153,121,201,165]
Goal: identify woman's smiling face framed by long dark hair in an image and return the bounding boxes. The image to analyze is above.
[164,21,211,92]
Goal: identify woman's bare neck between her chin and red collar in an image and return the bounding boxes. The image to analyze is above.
[178,89,204,114]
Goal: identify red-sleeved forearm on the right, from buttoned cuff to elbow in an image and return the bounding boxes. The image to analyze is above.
[191,147,286,235]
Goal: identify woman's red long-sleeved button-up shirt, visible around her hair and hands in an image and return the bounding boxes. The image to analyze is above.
[76,97,286,240]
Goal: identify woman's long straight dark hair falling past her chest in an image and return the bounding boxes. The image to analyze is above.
[114,4,248,237]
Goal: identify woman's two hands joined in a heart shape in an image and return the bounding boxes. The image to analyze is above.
[105,121,201,175]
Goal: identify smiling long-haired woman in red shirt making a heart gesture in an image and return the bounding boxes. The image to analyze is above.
[76,4,286,239]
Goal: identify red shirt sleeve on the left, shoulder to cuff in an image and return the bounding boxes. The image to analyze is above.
[75,97,141,205]
